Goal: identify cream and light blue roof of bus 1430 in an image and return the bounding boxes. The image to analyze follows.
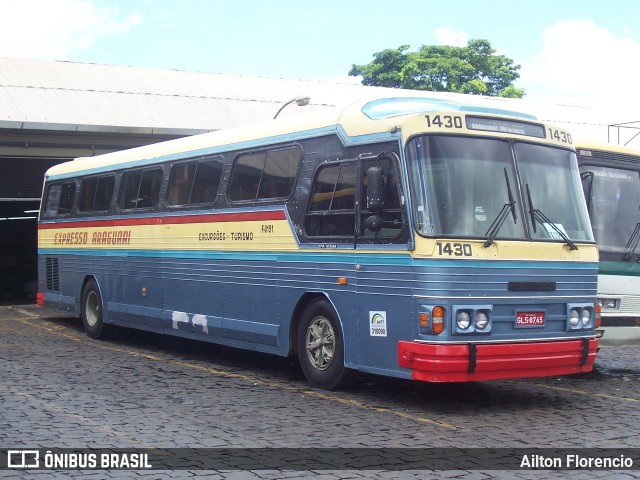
[45,92,536,177]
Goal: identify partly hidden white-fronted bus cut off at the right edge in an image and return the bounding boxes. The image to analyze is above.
[576,143,640,342]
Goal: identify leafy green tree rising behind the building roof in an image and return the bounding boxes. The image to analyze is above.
[349,40,524,98]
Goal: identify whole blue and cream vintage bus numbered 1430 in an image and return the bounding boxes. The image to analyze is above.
[38,97,599,389]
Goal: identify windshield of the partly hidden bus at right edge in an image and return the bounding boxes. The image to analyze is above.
[583,166,640,253]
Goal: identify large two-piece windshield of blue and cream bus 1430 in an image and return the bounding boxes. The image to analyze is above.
[407,135,592,241]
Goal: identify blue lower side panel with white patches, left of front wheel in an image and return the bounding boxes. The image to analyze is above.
[164,252,288,355]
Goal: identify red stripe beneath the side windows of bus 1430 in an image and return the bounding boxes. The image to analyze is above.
[38,210,287,230]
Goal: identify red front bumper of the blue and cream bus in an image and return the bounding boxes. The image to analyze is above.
[398,338,598,382]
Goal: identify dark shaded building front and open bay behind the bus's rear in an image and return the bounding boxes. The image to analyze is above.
[0,125,188,303]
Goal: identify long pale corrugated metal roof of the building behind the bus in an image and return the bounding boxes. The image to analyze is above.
[0,58,637,141]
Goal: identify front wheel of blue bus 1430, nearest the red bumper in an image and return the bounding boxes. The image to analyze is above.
[297,300,352,390]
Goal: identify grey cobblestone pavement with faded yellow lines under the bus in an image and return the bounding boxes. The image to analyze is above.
[0,305,640,479]
